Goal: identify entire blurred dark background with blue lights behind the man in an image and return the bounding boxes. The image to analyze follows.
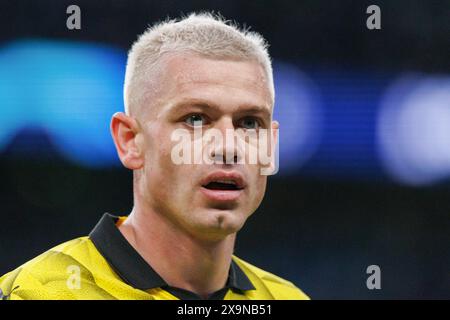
[0,0,450,299]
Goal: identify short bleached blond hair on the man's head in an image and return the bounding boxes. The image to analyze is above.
[124,12,275,114]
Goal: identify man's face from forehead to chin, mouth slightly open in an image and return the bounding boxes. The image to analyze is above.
[135,54,272,239]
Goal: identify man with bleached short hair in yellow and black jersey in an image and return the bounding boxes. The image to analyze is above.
[0,14,308,299]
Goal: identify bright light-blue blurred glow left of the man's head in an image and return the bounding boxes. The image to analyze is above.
[0,40,126,166]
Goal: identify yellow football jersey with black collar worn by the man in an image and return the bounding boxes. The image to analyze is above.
[0,214,309,300]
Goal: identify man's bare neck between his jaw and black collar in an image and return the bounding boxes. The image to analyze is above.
[119,208,236,297]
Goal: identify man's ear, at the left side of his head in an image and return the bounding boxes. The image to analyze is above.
[110,112,144,170]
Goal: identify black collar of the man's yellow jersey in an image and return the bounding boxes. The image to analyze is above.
[89,213,255,291]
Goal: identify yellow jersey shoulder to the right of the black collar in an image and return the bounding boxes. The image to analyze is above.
[233,256,310,300]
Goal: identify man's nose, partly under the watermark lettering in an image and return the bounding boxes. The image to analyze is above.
[209,118,243,164]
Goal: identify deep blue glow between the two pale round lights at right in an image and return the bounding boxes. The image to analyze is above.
[302,68,392,180]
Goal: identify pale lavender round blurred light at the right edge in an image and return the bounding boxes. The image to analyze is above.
[377,74,450,186]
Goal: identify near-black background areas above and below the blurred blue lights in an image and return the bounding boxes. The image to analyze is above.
[0,0,450,299]
